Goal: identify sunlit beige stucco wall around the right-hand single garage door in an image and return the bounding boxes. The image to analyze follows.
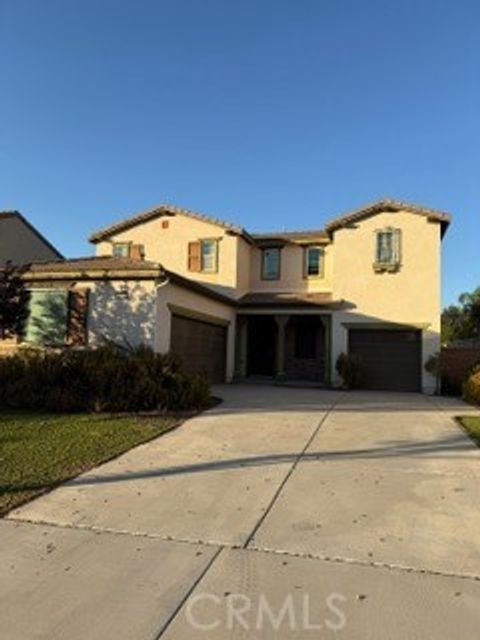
[332,212,441,392]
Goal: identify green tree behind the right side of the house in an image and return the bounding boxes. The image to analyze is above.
[442,287,480,343]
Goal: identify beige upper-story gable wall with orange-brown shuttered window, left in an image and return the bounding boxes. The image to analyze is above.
[96,214,245,296]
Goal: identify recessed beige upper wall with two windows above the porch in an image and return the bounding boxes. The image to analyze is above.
[250,245,332,292]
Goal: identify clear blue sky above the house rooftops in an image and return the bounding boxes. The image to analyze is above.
[0,0,480,303]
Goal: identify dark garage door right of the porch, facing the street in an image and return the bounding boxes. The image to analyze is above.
[349,329,421,391]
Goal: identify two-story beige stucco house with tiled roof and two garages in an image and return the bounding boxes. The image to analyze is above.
[22,200,450,392]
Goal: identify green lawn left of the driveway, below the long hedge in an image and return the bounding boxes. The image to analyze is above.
[0,413,178,516]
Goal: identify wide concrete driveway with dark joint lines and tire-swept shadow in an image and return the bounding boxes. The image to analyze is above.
[0,386,480,640]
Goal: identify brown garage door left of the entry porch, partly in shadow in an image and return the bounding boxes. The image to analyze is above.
[171,315,227,382]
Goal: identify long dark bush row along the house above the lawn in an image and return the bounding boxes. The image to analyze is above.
[0,345,210,413]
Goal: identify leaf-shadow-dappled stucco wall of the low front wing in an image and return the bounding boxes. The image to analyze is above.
[88,280,156,348]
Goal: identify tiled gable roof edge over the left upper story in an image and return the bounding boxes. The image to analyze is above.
[89,204,255,243]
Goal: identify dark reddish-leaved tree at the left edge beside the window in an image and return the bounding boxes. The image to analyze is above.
[0,262,28,340]
